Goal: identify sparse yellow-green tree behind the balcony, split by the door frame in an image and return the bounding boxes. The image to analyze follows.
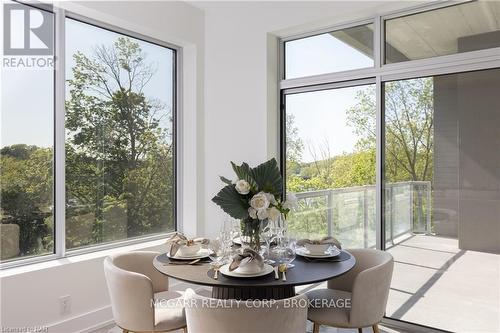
[348,78,434,182]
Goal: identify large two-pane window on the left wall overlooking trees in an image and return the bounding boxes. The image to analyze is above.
[0,3,177,267]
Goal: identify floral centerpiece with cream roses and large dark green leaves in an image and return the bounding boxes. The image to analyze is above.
[212,158,296,249]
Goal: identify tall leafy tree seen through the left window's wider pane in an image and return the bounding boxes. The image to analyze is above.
[66,38,173,246]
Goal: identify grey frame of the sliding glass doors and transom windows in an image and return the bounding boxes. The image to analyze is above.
[277,0,500,331]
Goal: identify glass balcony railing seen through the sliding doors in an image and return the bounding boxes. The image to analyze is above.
[288,181,432,247]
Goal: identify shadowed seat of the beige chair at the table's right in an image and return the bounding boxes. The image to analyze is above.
[306,289,351,327]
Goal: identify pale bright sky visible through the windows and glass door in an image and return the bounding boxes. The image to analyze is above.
[0,19,373,162]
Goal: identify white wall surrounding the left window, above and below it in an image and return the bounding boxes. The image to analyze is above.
[0,1,204,333]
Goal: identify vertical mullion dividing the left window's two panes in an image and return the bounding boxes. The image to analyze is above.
[54,8,66,257]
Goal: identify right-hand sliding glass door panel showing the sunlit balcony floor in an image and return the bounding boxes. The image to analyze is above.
[383,69,500,332]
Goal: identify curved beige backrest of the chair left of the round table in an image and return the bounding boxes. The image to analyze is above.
[104,251,168,331]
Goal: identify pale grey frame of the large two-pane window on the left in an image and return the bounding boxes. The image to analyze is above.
[0,0,183,270]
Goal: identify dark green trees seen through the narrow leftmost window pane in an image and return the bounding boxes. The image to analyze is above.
[0,144,53,256]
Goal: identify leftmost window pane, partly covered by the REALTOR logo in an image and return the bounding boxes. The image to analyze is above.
[0,3,54,261]
